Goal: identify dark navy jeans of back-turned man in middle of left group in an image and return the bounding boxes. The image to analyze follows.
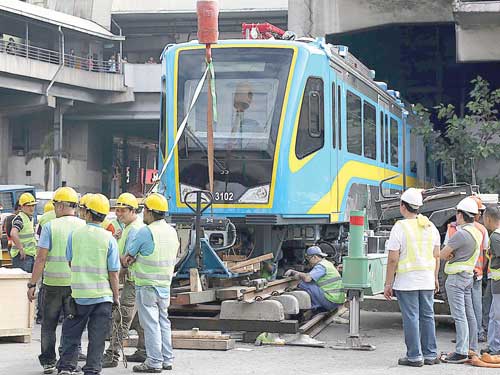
[57,302,112,375]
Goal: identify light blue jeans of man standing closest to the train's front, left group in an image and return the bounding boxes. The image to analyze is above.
[135,286,174,368]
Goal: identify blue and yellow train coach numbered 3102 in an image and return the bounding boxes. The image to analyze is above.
[159,38,426,260]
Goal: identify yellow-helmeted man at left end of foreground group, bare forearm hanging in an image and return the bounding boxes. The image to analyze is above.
[28,186,85,374]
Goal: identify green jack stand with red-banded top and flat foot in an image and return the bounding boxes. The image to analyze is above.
[332,211,387,350]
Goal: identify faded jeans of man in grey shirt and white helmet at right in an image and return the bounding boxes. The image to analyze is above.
[445,274,479,355]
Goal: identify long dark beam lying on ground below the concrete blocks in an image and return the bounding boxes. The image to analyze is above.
[169,316,299,333]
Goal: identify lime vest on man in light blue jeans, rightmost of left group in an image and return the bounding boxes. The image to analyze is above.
[134,220,179,288]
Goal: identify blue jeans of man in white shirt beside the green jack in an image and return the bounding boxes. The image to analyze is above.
[395,290,437,362]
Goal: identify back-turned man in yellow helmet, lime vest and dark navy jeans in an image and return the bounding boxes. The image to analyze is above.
[57,194,120,375]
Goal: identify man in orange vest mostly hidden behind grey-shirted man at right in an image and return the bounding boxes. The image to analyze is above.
[443,195,490,342]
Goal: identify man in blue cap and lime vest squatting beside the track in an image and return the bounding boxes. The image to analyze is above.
[285,246,345,312]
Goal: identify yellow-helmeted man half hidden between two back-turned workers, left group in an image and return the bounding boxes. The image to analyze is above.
[102,193,146,368]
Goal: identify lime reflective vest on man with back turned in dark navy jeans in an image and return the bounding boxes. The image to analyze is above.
[71,225,113,298]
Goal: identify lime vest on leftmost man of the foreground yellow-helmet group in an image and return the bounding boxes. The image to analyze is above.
[43,216,85,286]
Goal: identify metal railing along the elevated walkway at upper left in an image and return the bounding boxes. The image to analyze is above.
[0,40,123,74]
